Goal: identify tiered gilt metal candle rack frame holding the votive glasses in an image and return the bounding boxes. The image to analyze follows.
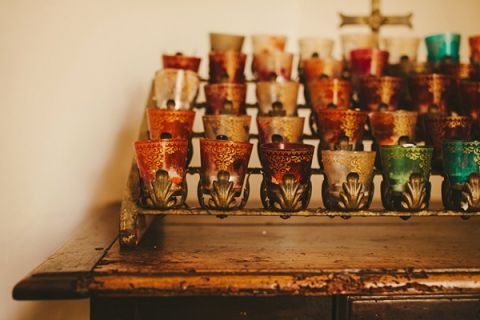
[120,80,480,247]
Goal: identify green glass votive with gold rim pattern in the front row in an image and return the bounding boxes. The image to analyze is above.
[380,144,433,211]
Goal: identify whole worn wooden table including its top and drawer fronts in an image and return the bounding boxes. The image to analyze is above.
[13,207,480,319]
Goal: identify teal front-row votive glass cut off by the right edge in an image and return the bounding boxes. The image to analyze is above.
[442,140,480,211]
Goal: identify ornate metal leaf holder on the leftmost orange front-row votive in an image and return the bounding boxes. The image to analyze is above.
[140,170,186,209]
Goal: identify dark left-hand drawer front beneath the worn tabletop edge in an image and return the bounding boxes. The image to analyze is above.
[91,297,333,320]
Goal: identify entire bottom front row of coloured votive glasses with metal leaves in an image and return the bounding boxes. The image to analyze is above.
[135,136,480,212]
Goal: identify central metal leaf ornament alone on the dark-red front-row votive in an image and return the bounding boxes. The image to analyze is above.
[270,174,305,211]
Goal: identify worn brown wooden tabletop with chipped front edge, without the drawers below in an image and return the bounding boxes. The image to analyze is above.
[14,202,480,299]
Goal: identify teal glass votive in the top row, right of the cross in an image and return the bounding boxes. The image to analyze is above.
[425,33,461,63]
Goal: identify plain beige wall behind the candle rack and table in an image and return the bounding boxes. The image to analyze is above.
[0,0,480,319]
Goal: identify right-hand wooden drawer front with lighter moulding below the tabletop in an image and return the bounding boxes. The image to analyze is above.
[337,296,480,320]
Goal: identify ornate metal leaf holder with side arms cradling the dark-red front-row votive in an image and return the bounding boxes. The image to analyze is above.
[260,173,312,212]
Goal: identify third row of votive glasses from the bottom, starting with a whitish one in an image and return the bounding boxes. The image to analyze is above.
[155,69,480,119]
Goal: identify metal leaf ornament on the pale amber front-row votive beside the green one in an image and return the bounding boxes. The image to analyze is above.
[338,172,368,210]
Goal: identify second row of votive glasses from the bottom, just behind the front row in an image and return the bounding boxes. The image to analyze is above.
[146,101,474,170]
